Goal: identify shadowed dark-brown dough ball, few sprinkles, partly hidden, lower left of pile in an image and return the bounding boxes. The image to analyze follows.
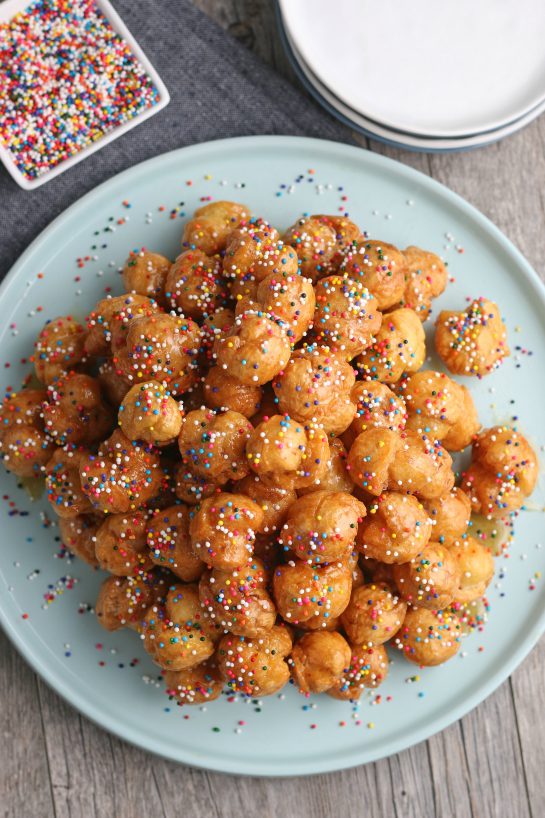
[146,505,205,582]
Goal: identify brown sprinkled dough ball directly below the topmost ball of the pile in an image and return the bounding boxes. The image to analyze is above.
[165,250,228,321]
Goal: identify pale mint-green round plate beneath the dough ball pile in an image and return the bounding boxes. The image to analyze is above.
[0,136,545,775]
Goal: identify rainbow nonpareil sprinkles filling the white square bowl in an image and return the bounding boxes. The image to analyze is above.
[0,0,160,179]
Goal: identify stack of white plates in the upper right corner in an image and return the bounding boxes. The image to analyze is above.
[278,0,545,151]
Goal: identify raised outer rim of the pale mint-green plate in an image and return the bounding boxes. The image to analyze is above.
[0,135,545,777]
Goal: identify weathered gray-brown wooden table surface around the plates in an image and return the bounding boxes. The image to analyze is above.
[0,0,545,818]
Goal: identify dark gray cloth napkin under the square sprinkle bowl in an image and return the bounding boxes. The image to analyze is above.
[0,0,350,278]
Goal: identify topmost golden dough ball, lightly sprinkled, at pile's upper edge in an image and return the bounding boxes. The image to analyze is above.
[182,202,250,256]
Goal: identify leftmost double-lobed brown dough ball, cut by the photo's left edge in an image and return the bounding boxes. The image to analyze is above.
[0,389,55,477]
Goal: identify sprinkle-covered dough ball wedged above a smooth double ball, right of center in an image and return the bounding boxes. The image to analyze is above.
[350,381,407,436]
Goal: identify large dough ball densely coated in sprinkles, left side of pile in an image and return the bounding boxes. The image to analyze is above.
[80,429,163,514]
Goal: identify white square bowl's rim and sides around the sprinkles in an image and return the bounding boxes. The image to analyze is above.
[0,0,170,190]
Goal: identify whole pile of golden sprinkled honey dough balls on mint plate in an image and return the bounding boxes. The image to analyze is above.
[0,202,538,704]
